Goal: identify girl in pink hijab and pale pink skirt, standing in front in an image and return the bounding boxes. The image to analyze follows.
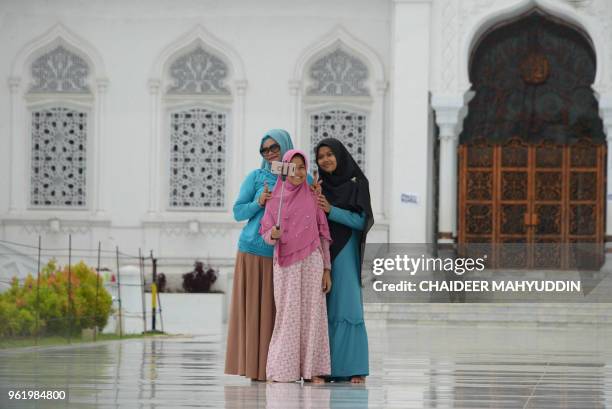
[259,149,331,383]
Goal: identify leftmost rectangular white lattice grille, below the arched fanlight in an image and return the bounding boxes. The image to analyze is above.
[30,107,87,208]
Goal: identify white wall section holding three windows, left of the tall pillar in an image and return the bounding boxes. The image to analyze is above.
[0,0,391,278]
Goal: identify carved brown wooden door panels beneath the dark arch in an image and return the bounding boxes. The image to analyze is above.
[458,139,606,269]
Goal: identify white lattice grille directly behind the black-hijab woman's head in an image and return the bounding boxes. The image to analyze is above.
[310,110,366,169]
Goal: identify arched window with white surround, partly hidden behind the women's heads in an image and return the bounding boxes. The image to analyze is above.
[289,27,389,221]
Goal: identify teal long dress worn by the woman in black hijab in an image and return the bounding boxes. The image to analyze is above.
[327,206,369,378]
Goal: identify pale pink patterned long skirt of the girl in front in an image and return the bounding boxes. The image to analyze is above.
[266,249,331,382]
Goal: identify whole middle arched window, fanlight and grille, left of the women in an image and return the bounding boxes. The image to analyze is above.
[165,44,232,210]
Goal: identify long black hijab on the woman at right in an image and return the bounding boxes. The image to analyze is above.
[315,138,374,276]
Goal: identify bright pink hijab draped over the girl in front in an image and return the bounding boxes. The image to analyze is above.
[259,149,331,267]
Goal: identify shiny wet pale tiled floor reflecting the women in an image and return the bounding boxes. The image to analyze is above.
[0,325,612,409]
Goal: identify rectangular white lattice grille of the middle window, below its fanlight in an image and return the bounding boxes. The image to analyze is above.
[169,108,227,208]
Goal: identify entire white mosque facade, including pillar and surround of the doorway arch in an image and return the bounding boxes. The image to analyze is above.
[0,0,612,280]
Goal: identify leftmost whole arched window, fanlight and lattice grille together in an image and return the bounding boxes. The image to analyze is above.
[27,44,92,208]
